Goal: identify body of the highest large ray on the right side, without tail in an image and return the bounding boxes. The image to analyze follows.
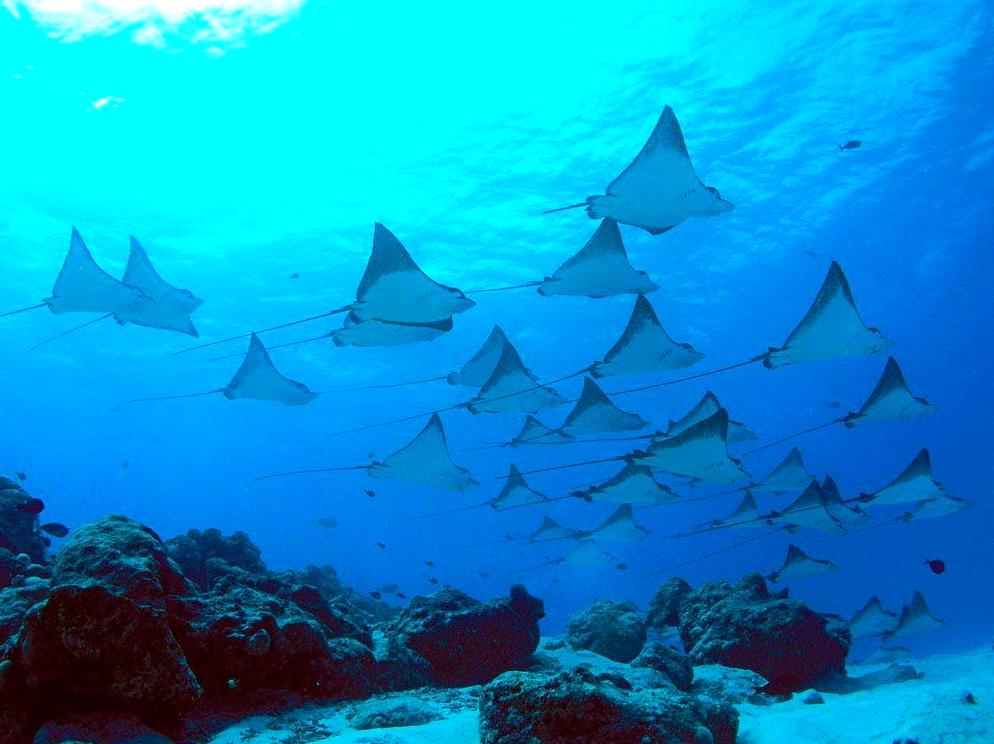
[763,261,894,367]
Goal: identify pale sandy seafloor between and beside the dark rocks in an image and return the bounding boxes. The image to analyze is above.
[203,639,994,744]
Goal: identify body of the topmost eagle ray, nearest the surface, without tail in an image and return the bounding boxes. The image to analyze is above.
[587,106,734,235]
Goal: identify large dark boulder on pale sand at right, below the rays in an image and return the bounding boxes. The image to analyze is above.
[653,574,852,693]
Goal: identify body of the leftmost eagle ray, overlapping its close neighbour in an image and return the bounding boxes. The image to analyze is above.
[45,227,151,317]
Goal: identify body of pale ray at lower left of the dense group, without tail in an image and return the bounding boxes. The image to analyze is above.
[366,413,480,491]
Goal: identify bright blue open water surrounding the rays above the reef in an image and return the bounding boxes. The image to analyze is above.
[0,0,994,650]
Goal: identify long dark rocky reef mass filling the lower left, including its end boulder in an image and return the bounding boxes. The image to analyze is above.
[0,517,544,742]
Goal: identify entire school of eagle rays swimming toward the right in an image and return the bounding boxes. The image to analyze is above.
[0,101,969,652]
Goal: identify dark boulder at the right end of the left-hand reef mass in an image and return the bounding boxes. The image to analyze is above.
[385,586,545,687]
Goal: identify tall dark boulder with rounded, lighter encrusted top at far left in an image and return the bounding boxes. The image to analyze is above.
[17,517,202,718]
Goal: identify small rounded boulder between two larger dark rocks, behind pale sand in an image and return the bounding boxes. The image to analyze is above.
[566,600,646,663]
